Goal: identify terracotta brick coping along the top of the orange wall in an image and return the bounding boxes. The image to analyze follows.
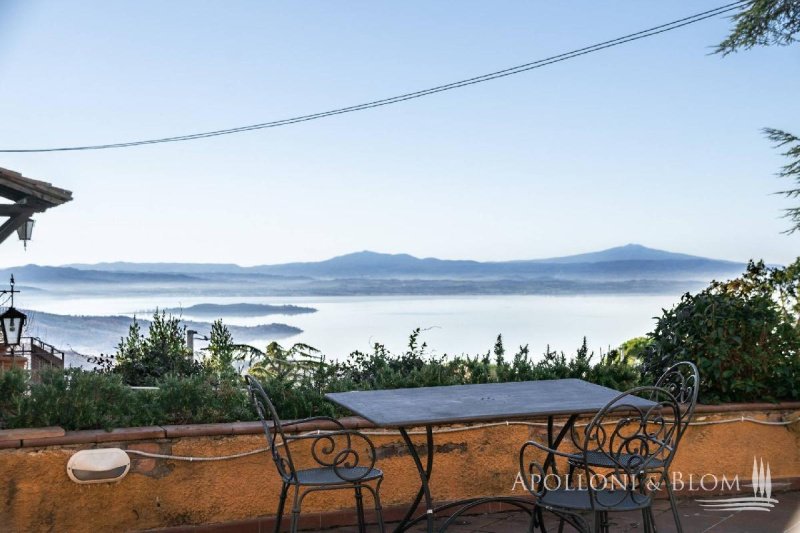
[0,402,800,450]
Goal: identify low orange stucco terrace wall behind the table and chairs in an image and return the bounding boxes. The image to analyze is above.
[0,403,800,531]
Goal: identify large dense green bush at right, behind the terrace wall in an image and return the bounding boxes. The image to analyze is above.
[645,259,800,403]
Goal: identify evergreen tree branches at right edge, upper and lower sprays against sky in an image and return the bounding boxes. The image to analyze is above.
[715,0,800,234]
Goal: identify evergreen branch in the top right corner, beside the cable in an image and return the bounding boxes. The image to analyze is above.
[715,0,800,55]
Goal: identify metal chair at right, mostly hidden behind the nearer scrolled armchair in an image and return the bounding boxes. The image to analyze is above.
[569,361,700,533]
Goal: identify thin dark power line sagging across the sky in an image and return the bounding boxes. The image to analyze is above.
[0,0,751,153]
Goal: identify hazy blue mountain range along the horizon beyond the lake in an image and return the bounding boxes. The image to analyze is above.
[7,244,745,296]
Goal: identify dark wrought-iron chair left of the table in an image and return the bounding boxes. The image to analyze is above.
[245,376,384,533]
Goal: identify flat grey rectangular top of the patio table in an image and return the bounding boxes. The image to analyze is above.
[325,379,654,427]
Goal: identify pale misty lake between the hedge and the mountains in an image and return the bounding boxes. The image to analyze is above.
[25,293,680,358]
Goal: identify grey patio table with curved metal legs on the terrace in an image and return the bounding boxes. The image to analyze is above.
[325,379,653,533]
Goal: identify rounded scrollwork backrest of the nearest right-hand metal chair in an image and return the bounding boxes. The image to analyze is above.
[581,387,681,509]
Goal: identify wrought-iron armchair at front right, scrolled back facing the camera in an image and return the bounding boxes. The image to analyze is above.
[519,387,681,533]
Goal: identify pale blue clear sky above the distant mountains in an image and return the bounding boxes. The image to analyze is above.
[0,0,800,267]
